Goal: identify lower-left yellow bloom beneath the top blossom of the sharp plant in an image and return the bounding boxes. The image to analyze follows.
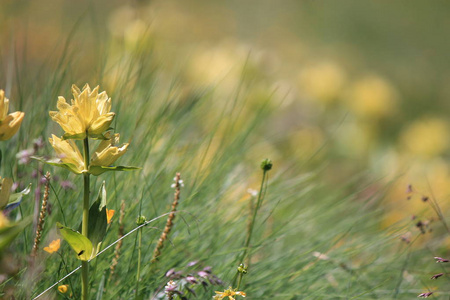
[49,134,86,174]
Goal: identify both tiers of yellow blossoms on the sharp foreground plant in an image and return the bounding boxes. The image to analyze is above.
[49,84,129,175]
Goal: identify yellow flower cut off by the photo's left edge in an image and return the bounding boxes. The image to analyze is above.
[0,90,25,141]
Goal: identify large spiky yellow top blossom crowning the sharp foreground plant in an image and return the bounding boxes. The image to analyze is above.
[50,84,115,139]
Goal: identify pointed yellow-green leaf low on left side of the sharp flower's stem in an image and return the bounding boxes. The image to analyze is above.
[56,222,95,261]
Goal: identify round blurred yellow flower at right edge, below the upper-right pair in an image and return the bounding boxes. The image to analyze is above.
[400,118,450,158]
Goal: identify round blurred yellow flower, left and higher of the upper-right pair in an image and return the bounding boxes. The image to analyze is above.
[299,62,346,104]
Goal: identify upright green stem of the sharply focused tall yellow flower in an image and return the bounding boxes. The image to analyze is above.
[81,136,90,300]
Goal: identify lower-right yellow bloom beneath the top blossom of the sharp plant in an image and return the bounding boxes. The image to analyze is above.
[91,132,129,167]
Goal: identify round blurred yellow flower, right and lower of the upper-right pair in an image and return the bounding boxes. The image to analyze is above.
[345,75,397,118]
